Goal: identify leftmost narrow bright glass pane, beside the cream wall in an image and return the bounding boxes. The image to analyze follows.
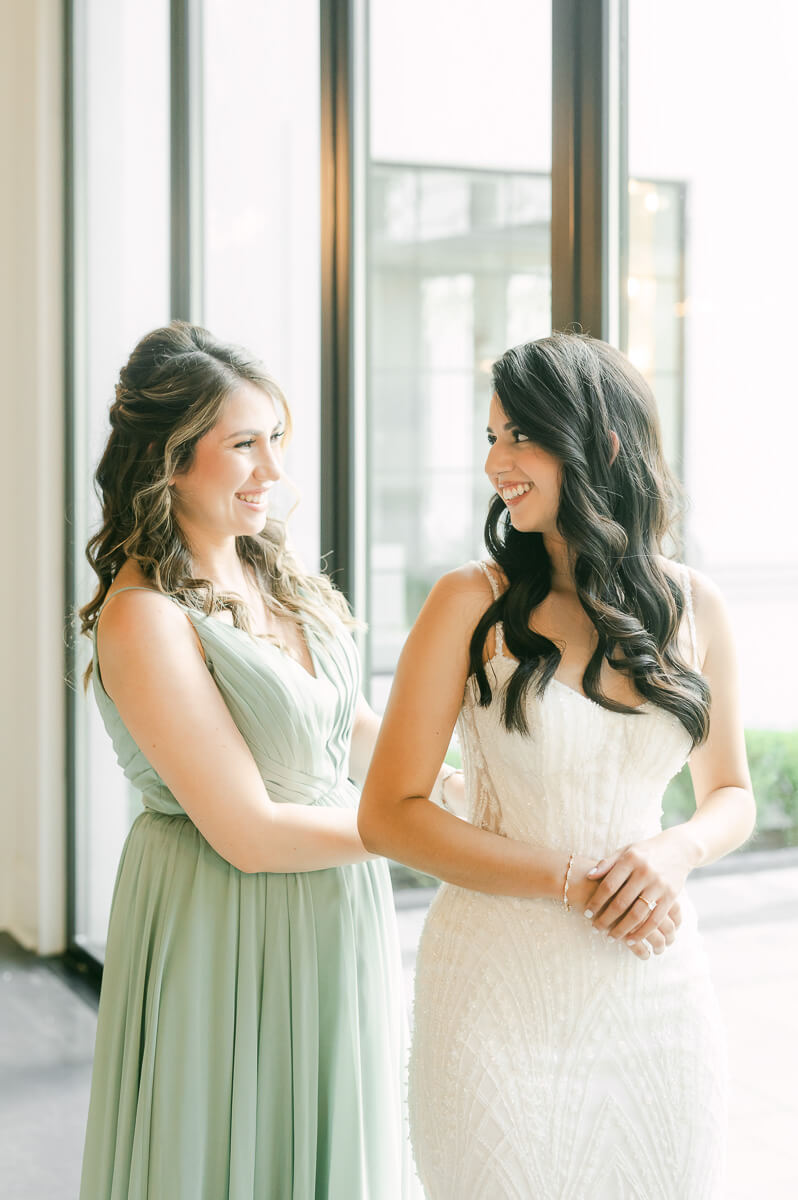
[72,0,169,958]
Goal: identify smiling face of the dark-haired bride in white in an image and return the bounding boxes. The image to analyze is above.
[485,392,562,534]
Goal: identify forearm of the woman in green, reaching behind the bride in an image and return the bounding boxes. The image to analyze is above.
[242,803,374,874]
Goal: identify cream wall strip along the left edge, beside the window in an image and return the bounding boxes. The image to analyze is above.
[0,0,66,954]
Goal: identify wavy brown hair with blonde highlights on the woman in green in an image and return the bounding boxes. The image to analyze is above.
[79,320,354,680]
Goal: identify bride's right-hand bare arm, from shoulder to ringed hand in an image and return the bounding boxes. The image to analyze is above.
[589,574,756,938]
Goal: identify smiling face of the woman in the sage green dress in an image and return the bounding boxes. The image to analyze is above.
[172,383,286,541]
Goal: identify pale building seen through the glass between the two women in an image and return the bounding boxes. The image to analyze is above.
[368,163,551,704]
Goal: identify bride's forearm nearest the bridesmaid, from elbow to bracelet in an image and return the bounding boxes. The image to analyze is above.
[359,785,569,899]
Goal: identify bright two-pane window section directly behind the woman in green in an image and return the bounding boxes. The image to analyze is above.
[68,0,320,959]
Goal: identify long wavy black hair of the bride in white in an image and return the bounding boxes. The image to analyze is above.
[470,332,709,745]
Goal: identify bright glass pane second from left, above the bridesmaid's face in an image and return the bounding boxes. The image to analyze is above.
[203,0,320,565]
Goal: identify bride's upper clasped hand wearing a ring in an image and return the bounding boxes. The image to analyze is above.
[586,826,696,942]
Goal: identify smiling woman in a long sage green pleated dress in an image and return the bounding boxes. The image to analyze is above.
[80,322,427,1200]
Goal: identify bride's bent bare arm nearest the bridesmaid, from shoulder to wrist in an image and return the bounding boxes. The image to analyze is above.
[358,566,592,899]
